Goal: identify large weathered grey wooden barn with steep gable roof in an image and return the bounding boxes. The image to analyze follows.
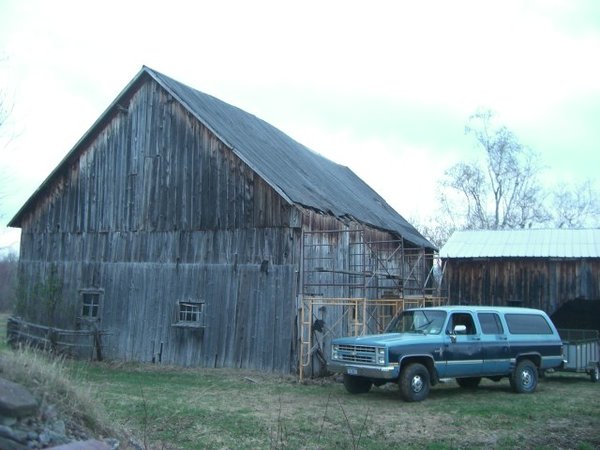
[9,67,434,373]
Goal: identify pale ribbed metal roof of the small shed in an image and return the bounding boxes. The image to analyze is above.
[440,229,600,258]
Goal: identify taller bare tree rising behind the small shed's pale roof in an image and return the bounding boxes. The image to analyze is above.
[442,110,548,229]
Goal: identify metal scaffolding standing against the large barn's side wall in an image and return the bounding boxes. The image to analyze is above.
[299,229,446,379]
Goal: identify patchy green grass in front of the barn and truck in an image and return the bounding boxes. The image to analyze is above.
[0,312,600,450]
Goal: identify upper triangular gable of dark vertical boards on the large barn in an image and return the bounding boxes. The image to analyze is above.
[22,82,294,233]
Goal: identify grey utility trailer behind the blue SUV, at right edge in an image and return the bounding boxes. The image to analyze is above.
[558,329,600,383]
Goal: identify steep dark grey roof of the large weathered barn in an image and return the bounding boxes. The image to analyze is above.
[9,66,434,248]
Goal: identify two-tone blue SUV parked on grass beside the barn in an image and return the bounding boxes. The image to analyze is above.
[328,306,564,402]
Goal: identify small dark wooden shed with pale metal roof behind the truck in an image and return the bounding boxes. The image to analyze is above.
[440,229,600,314]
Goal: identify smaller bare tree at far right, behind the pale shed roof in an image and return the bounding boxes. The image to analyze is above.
[550,180,600,228]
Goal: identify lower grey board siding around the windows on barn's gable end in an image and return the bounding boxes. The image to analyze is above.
[17,262,297,373]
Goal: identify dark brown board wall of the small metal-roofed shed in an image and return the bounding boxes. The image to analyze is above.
[444,258,600,314]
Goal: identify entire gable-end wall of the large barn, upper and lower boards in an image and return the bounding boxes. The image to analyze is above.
[19,77,301,372]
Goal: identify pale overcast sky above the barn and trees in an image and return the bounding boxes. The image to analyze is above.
[0,0,600,251]
